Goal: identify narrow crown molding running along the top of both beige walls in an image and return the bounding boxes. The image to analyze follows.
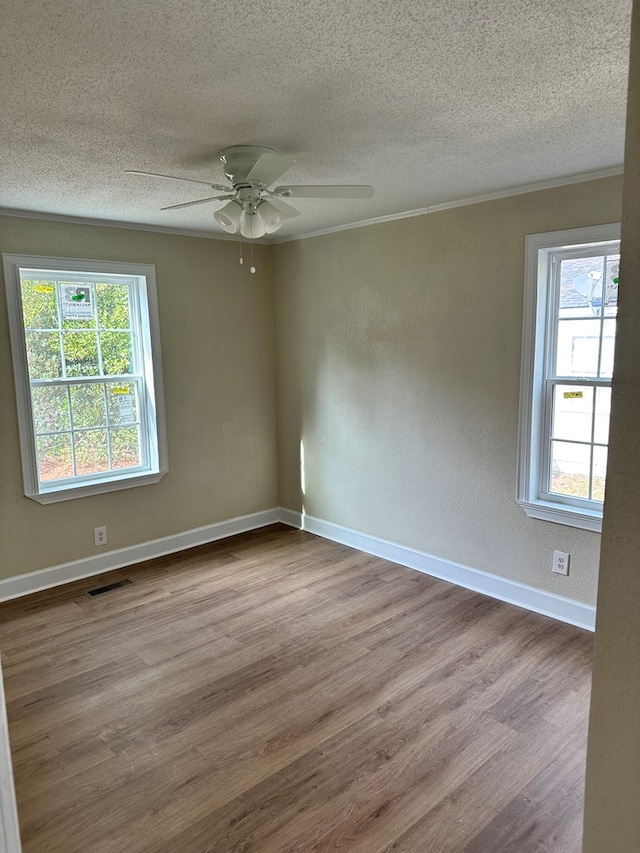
[0,166,623,246]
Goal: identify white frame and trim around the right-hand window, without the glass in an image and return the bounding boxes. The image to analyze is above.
[516,223,620,533]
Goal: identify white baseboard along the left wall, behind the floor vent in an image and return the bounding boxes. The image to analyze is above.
[0,509,280,601]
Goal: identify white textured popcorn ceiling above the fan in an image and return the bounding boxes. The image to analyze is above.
[0,0,631,236]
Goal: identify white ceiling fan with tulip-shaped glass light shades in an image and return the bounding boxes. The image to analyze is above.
[126,145,373,240]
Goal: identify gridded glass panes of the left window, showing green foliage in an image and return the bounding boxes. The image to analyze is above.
[20,269,149,488]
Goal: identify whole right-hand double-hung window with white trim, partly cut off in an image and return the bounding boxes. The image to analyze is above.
[518,225,620,530]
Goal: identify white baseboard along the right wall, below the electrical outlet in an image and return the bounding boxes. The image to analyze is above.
[280,509,596,631]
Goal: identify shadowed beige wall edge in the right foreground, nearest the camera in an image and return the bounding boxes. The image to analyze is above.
[584,0,640,853]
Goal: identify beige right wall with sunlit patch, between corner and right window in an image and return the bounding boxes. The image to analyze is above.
[273,178,621,604]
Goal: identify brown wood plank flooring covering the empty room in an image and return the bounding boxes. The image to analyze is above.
[0,525,592,853]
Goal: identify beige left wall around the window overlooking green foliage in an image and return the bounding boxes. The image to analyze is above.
[0,216,278,578]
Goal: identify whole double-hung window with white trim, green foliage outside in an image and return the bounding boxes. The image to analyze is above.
[4,255,167,503]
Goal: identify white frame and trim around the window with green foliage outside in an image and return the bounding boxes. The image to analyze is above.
[3,254,168,504]
